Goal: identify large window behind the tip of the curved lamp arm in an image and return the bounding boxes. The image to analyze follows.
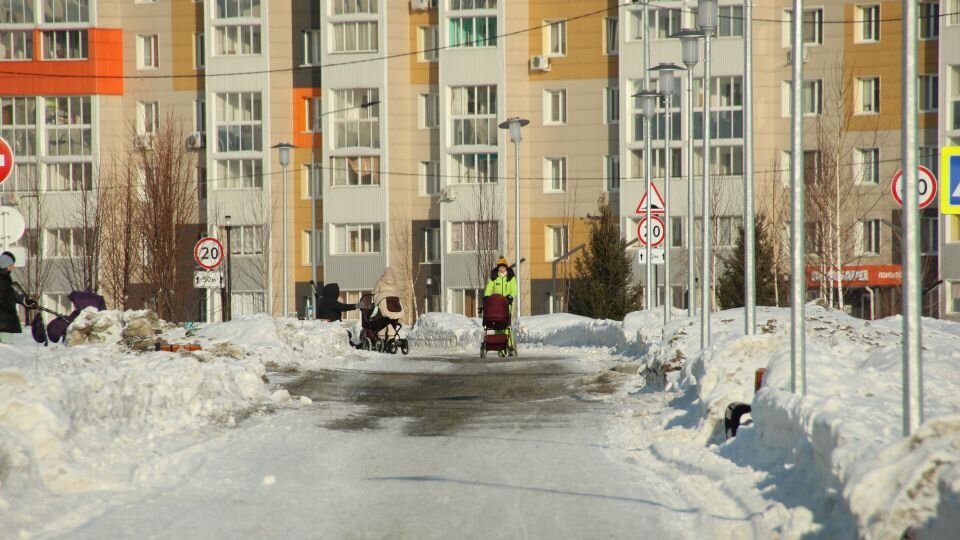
[333,88,380,148]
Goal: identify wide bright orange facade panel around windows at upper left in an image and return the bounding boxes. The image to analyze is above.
[0,28,123,95]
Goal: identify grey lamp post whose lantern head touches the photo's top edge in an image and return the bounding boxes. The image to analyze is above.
[697,0,720,349]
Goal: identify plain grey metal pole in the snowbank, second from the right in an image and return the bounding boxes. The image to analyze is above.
[790,0,808,395]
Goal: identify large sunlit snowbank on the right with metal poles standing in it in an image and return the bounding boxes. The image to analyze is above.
[645,304,960,538]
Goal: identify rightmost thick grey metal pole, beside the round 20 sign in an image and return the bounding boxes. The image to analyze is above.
[900,0,923,437]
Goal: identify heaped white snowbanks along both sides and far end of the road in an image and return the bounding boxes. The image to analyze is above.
[0,305,960,539]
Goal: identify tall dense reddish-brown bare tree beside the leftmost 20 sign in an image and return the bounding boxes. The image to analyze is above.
[135,113,198,320]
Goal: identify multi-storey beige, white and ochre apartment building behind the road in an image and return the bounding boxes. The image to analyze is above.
[0,0,944,320]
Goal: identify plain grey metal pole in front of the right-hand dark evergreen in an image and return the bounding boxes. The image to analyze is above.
[743,0,757,336]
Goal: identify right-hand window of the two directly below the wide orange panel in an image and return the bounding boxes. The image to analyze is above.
[44,96,93,156]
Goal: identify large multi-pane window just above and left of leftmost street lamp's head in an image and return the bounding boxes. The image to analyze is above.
[214,92,263,152]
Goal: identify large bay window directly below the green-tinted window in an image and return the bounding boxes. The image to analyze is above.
[450,86,498,146]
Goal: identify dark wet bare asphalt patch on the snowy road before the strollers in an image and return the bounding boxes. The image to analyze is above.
[284,354,620,436]
